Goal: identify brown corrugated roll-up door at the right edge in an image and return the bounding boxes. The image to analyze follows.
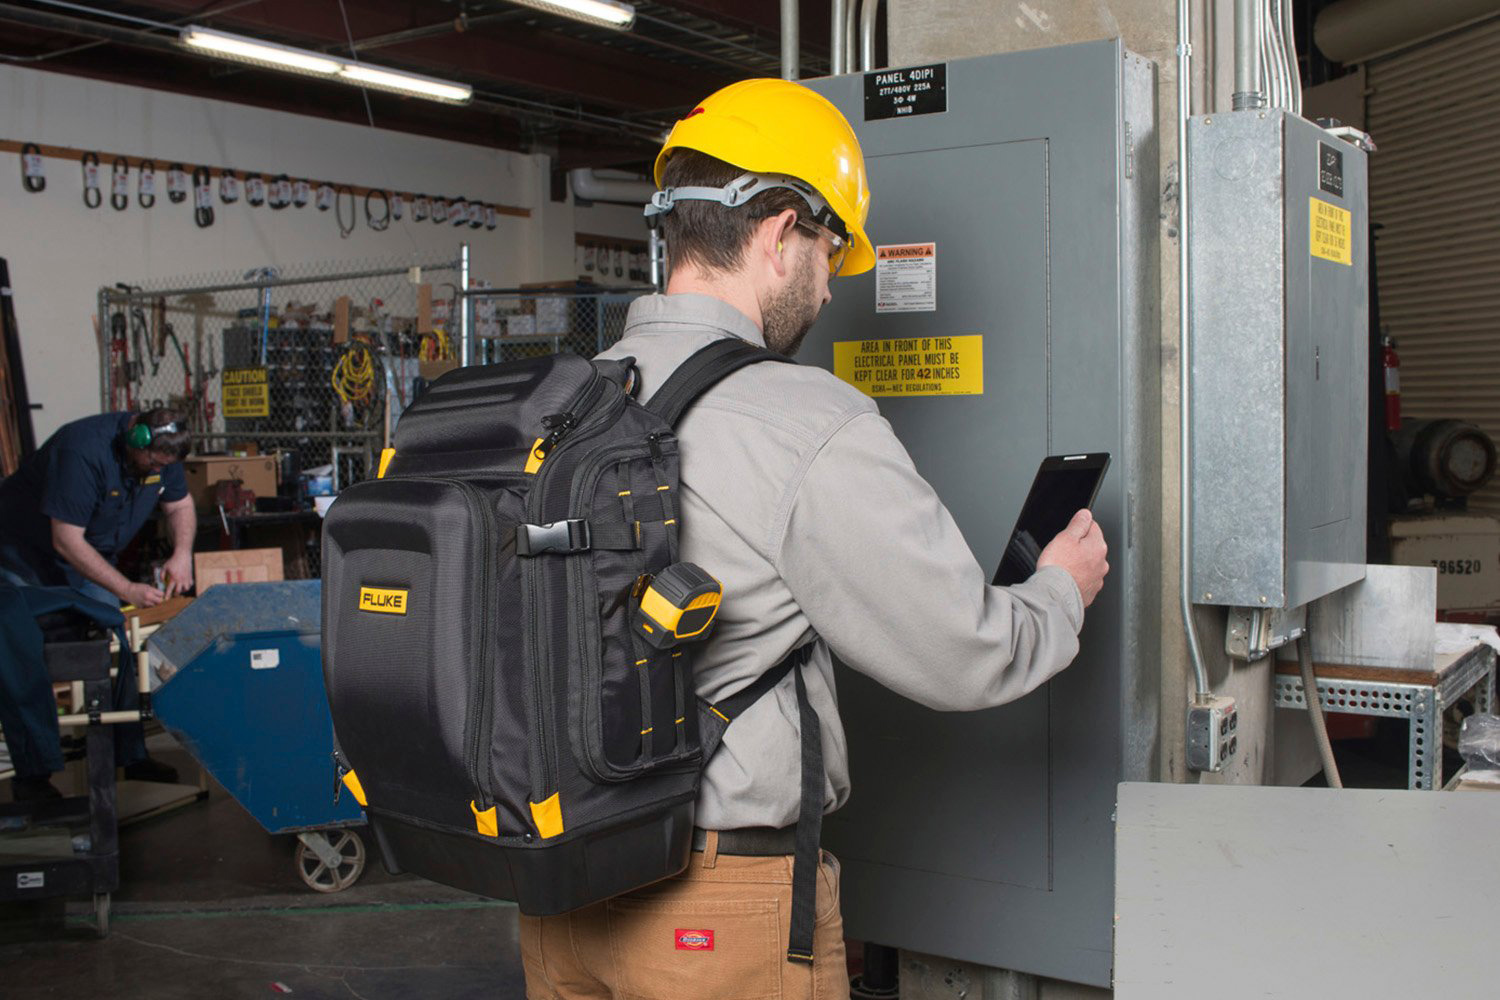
[1367,18,1500,514]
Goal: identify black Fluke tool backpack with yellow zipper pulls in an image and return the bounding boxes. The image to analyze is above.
[323,340,822,951]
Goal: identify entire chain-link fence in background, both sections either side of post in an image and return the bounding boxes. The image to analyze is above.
[98,262,650,579]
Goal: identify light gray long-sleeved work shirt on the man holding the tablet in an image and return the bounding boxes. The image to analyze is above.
[600,295,1083,829]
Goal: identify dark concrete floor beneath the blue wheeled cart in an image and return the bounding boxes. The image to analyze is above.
[0,735,525,1000]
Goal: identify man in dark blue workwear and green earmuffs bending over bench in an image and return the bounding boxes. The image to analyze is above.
[0,409,198,801]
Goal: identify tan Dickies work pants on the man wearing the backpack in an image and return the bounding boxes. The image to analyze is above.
[521,832,849,1000]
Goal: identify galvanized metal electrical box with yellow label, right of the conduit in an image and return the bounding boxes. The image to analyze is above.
[1188,111,1370,607]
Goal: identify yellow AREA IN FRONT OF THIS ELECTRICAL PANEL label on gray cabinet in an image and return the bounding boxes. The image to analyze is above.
[834,333,984,396]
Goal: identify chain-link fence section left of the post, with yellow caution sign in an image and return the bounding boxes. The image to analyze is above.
[99,259,461,489]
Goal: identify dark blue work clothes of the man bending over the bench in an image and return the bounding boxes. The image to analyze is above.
[0,414,188,778]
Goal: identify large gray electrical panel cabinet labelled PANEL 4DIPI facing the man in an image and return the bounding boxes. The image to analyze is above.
[800,42,1161,985]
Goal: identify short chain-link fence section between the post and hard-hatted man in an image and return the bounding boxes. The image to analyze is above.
[464,288,651,364]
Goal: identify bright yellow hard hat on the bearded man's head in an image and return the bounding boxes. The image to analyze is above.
[656,79,875,274]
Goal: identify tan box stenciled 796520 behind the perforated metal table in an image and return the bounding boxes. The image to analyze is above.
[1391,514,1500,612]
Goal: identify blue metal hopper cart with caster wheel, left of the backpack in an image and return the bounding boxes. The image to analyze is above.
[147,580,366,892]
